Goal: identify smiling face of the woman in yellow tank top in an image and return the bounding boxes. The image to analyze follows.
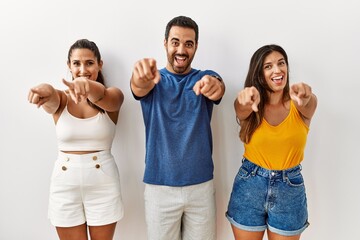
[263,51,288,92]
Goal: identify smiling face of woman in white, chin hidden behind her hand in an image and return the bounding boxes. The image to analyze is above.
[68,48,102,81]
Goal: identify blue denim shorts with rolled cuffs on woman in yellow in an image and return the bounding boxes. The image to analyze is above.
[226,158,309,236]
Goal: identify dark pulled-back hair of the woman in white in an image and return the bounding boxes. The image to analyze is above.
[68,39,105,113]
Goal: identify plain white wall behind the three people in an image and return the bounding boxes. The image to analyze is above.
[0,0,360,240]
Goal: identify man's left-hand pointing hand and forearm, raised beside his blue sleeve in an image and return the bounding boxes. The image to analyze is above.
[130,58,160,97]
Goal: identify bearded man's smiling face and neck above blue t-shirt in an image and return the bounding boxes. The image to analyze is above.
[164,26,197,74]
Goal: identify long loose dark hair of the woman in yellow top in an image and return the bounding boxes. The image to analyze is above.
[238,44,290,143]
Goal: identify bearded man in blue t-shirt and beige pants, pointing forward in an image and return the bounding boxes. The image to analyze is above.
[131,16,225,240]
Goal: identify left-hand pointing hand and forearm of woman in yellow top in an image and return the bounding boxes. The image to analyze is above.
[234,87,260,121]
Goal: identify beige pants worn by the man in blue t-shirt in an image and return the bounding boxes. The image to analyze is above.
[144,180,216,240]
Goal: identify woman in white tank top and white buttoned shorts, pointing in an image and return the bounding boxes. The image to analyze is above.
[28,39,124,240]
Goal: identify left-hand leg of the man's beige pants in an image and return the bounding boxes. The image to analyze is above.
[144,184,184,240]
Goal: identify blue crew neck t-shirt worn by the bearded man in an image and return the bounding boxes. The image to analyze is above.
[135,68,220,186]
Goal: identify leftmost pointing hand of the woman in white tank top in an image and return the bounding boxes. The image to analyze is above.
[28,83,61,114]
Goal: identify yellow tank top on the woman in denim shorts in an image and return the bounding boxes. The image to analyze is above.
[244,101,309,170]
